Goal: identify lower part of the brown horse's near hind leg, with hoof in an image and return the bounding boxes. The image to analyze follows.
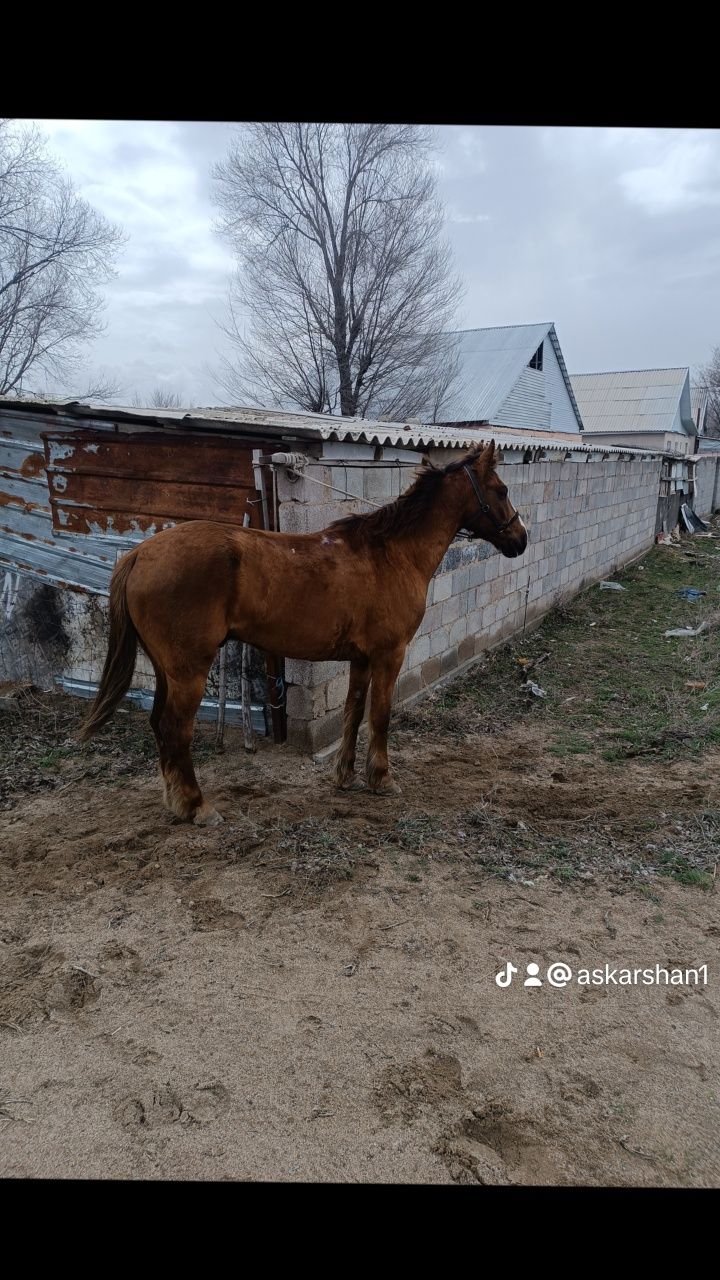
[150,668,217,827]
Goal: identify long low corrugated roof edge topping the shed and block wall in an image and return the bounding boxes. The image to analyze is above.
[0,401,648,463]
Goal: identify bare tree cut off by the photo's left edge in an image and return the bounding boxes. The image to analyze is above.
[0,120,124,396]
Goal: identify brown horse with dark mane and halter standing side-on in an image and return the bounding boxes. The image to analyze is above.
[82,442,528,826]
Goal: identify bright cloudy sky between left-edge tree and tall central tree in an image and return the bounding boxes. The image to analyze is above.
[29,120,233,403]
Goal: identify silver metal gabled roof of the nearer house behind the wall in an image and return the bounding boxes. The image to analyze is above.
[442,321,583,430]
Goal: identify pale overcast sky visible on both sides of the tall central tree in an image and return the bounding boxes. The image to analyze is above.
[36,120,720,404]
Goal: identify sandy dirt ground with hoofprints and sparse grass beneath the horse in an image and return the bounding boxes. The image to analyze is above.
[0,544,720,1187]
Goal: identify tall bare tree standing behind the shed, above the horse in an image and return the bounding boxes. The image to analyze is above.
[214,123,460,419]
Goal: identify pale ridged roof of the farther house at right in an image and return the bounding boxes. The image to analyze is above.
[571,369,696,435]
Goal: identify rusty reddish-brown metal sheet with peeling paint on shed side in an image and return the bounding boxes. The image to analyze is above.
[44,429,261,538]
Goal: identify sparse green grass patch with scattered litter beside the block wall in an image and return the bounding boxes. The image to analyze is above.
[418,538,720,763]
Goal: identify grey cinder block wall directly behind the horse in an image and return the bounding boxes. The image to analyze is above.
[278,444,660,751]
